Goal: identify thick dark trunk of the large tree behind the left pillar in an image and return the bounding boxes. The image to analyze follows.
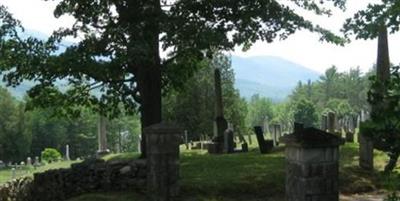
[132,0,161,158]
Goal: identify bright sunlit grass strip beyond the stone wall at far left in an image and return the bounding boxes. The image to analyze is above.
[0,161,79,185]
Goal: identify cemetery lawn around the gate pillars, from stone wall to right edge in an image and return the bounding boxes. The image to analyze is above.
[65,143,400,201]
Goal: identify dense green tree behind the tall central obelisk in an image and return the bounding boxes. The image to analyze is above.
[163,53,247,139]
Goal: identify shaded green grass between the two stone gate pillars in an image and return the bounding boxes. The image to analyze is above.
[181,150,285,200]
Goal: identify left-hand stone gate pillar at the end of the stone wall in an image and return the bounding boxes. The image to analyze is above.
[144,123,181,201]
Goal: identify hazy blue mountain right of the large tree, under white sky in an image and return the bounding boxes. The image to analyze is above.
[232,56,320,101]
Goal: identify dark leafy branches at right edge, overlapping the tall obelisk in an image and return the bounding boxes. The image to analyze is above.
[360,66,400,171]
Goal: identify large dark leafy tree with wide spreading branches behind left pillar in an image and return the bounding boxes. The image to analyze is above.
[0,0,345,157]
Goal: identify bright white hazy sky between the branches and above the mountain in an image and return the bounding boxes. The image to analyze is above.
[0,0,394,72]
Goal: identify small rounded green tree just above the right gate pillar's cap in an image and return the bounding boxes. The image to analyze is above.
[293,99,318,127]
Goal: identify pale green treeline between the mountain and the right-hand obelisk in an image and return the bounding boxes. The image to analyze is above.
[286,66,372,130]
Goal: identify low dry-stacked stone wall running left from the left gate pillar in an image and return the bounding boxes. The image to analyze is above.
[0,159,146,201]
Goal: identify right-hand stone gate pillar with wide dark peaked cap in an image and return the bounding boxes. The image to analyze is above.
[281,124,344,201]
